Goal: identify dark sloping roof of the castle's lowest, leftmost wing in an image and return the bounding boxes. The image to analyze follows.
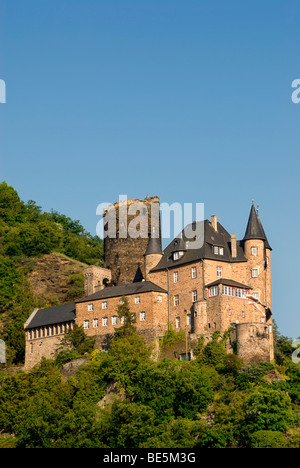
[26,302,76,330]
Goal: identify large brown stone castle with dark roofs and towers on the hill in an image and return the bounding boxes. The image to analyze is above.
[24,197,274,368]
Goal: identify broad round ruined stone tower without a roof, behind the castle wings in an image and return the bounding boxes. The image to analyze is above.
[104,197,161,285]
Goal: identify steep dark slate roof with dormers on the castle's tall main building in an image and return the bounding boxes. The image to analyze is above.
[151,220,247,271]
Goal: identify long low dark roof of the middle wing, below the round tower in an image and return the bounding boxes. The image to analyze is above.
[77,281,167,303]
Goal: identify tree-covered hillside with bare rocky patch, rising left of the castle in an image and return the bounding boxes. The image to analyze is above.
[0,182,103,364]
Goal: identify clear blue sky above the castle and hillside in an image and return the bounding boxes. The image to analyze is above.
[0,0,300,337]
